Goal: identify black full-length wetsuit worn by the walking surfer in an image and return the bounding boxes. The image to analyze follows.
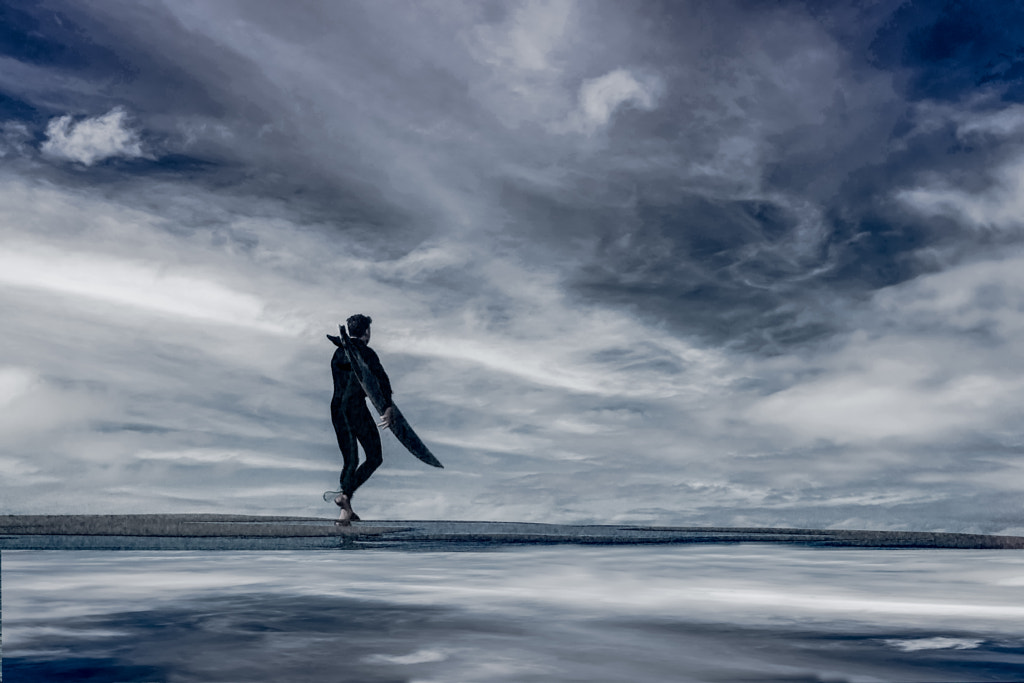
[331,339,391,497]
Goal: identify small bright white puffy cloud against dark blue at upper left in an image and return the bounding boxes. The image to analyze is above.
[40,106,146,166]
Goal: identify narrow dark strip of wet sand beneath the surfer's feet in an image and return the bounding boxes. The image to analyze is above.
[0,514,1024,551]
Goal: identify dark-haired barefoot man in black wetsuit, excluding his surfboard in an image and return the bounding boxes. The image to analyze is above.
[331,313,394,526]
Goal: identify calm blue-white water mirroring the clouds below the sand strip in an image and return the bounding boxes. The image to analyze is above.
[2,545,1024,683]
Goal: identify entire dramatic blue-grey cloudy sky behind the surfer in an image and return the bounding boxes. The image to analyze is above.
[0,0,1024,533]
